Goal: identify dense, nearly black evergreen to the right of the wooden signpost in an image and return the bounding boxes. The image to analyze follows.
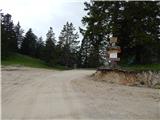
[114,1,160,64]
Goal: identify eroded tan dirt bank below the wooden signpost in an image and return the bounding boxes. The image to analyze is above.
[92,70,160,88]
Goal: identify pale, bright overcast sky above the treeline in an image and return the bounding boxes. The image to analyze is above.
[0,0,89,40]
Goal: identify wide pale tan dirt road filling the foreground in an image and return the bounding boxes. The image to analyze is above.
[2,68,160,120]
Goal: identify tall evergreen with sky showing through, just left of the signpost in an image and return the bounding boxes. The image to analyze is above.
[81,1,109,67]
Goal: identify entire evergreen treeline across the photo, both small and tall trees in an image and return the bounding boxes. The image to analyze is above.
[1,1,160,67]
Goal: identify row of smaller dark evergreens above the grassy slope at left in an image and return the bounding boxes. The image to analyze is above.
[1,13,79,68]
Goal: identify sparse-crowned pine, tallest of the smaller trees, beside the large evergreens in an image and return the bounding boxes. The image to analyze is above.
[58,22,79,67]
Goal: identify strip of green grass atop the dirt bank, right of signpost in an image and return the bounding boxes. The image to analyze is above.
[121,64,160,71]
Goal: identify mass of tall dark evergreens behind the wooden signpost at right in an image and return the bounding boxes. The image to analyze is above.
[80,1,160,67]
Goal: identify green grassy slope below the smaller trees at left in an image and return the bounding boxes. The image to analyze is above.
[1,53,64,70]
